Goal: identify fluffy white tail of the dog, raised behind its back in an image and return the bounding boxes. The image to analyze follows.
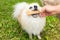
[13,2,28,18]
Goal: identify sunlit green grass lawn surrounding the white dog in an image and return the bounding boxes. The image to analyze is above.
[0,0,60,40]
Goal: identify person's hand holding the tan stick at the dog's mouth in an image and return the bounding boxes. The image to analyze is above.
[40,5,56,17]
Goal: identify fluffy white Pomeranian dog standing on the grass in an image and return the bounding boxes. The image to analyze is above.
[13,2,46,39]
